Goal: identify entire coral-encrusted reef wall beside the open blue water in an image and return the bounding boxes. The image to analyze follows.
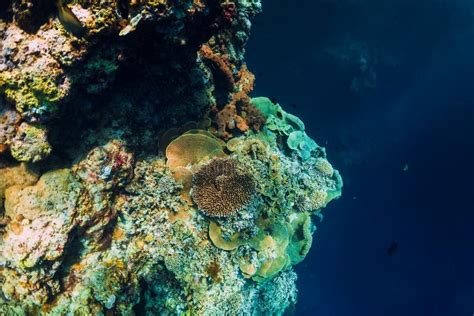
[0,0,342,316]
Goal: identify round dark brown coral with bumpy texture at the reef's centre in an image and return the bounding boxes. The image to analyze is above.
[192,158,255,217]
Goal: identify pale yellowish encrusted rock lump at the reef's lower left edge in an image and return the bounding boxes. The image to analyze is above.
[0,169,79,305]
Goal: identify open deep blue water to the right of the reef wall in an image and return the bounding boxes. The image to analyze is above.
[247,0,474,316]
